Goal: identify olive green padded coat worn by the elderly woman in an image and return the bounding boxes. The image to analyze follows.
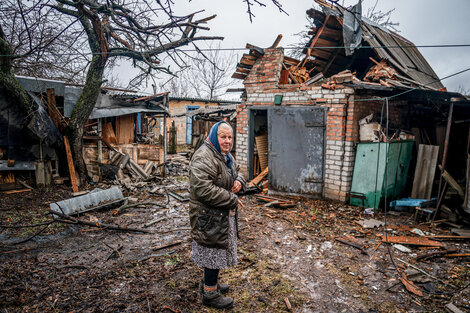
[189,140,245,249]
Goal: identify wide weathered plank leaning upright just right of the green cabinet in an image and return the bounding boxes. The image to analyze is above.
[411,145,439,200]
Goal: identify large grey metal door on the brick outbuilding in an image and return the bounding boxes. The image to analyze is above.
[268,107,326,197]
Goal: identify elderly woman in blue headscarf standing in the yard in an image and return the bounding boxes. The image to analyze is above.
[189,122,245,309]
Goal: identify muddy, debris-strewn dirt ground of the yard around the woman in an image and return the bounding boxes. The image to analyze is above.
[0,160,470,312]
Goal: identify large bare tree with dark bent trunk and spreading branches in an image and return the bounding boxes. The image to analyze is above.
[0,0,223,179]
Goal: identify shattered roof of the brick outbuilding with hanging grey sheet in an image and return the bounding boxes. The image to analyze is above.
[232,0,445,91]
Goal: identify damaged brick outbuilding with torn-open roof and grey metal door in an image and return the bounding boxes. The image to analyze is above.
[232,9,468,201]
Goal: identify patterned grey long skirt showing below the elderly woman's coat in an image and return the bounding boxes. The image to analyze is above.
[193,216,238,269]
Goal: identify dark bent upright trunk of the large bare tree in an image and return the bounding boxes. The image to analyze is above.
[66,55,106,183]
